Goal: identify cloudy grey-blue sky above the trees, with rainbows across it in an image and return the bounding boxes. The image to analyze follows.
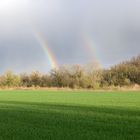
[0,0,140,73]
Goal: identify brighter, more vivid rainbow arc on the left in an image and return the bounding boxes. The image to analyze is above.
[34,30,58,69]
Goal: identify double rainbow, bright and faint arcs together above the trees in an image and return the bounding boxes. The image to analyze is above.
[34,27,102,69]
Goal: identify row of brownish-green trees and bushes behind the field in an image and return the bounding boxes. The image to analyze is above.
[0,55,140,89]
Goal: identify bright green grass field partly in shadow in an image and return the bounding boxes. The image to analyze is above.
[0,91,140,140]
